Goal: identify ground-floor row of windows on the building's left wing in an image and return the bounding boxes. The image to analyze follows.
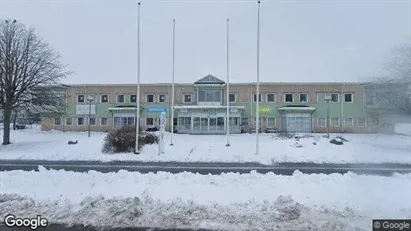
[54,117,161,126]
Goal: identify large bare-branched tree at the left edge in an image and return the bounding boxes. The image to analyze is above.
[0,20,69,145]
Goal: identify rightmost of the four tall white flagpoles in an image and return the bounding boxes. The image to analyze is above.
[255,1,260,155]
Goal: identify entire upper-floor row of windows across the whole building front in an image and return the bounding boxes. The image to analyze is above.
[77,93,354,103]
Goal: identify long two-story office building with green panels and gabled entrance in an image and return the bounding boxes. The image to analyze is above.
[42,75,390,134]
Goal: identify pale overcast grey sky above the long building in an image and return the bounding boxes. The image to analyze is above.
[0,0,411,84]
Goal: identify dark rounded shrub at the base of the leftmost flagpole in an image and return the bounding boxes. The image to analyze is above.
[102,127,158,153]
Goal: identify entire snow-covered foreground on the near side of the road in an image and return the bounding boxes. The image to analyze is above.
[0,167,411,230]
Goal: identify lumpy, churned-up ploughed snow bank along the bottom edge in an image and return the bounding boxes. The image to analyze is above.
[0,194,366,230]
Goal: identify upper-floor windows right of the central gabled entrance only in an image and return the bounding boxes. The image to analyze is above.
[248,92,354,103]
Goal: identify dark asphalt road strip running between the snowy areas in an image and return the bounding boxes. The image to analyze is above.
[0,160,411,176]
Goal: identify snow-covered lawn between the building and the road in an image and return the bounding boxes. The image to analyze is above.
[0,125,411,164]
